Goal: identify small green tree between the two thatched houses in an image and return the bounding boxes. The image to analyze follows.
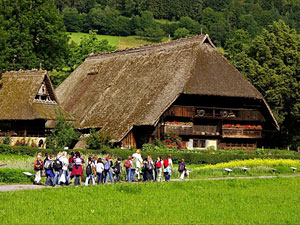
[46,112,80,149]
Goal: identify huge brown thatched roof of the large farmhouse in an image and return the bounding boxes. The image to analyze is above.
[56,35,276,141]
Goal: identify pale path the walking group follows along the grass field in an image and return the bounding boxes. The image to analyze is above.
[0,174,300,192]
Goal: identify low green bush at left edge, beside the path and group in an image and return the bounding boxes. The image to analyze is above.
[0,168,34,183]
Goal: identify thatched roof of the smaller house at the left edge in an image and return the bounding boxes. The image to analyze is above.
[0,70,58,120]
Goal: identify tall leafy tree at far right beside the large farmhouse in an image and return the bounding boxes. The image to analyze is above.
[227,20,300,148]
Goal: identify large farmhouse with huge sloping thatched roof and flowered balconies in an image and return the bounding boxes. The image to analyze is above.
[56,35,278,149]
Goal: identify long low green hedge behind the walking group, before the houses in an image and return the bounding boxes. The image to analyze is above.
[0,145,300,164]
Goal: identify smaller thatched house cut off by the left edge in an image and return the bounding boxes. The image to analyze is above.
[0,70,59,147]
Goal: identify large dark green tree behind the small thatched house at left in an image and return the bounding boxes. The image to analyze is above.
[0,0,68,70]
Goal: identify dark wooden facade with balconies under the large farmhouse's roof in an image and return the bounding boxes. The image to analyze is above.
[141,95,268,149]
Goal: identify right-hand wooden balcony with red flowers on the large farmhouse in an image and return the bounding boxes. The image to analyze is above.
[222,127,262,138]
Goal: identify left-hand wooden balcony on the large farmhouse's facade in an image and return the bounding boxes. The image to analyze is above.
[164,125,220,136]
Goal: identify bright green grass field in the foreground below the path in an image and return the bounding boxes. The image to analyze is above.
[0,178,300,224]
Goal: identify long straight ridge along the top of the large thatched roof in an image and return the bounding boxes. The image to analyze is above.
[87,34,208,59]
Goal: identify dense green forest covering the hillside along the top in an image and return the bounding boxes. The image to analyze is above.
[55,0,300,47]
